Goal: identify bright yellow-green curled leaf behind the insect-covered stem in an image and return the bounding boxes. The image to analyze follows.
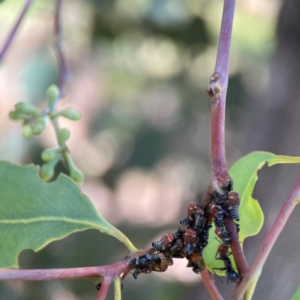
[204,151,300,274]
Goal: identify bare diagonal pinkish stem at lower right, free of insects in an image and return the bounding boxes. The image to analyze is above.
[231,177,300,300]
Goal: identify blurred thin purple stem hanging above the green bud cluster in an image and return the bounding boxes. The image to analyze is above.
[54,0,69,102]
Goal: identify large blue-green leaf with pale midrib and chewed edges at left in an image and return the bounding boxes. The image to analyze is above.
[0,161,136,268]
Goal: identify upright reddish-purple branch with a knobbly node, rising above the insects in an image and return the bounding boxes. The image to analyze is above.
[201,0,249,288]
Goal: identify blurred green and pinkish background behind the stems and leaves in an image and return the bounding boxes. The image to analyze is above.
[0,0,300,300]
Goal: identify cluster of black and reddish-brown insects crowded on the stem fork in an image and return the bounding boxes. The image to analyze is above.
[130,192,240,282]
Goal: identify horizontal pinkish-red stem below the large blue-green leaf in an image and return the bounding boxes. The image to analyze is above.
[0,249,152,281]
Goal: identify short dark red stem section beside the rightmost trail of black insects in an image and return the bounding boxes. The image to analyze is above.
[224,218,250,276]
